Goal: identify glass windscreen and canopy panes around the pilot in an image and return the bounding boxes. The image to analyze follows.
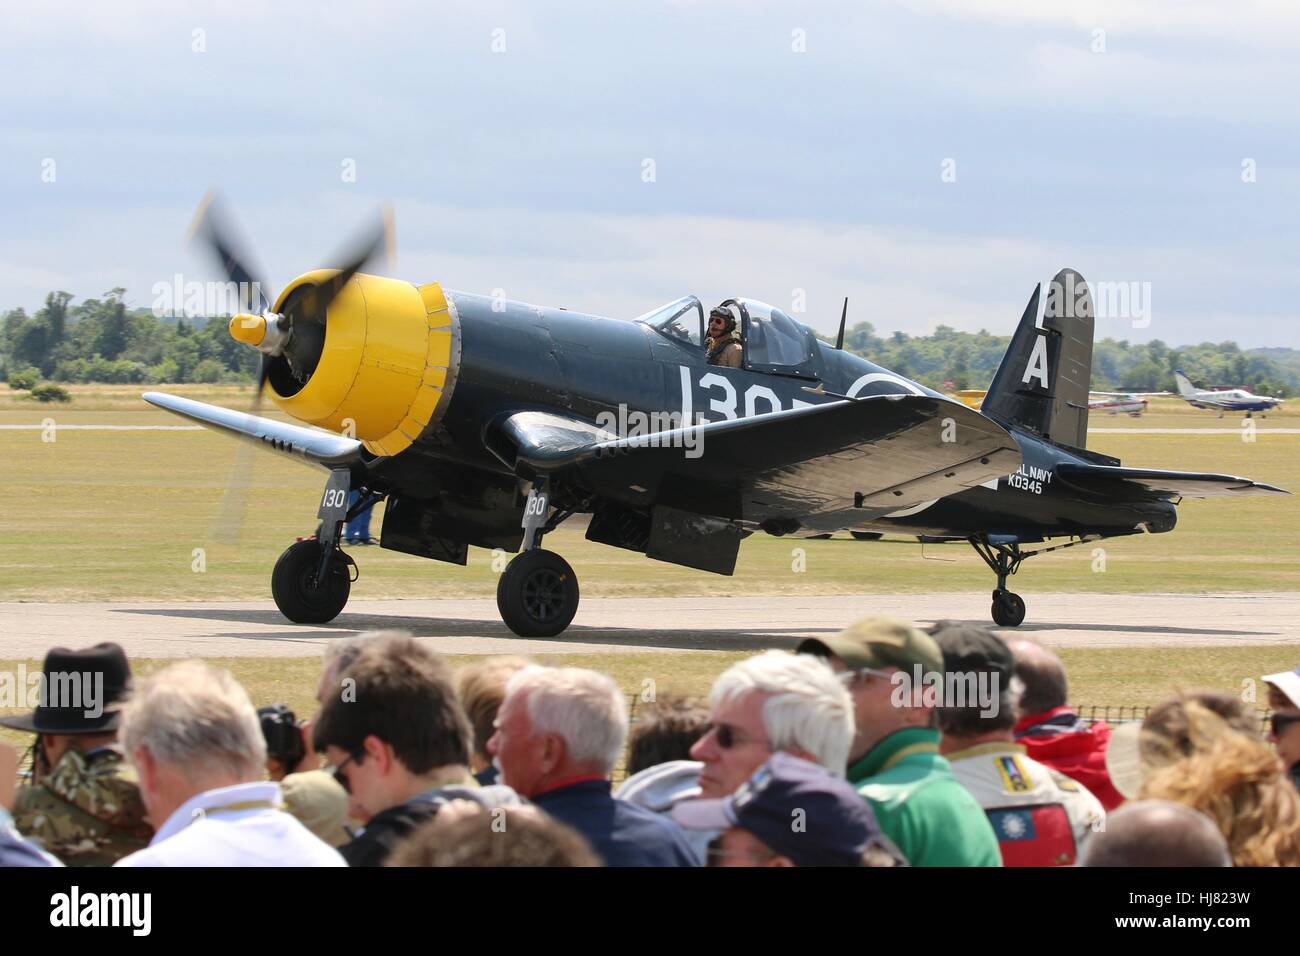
[636,295,816,377]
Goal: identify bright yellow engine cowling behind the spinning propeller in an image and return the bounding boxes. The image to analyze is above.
[268,269,460,455]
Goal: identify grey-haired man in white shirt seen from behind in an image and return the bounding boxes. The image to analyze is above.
[117,661,345,866]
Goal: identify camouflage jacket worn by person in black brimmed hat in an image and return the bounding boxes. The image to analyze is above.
[13,747,153,866]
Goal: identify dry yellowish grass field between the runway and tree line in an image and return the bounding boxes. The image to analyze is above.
[0,386,1300,601]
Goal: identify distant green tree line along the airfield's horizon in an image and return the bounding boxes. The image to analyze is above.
[0,289,1300,395]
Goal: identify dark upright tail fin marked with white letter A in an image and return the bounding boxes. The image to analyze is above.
[980,269,1093,449]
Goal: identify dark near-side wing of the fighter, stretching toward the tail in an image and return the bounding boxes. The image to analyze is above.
[489,395,1021,529]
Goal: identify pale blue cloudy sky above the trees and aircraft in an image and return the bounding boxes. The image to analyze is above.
[0,0,1300,347]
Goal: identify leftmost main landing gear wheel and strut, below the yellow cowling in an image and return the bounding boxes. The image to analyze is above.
[270,468,384,624]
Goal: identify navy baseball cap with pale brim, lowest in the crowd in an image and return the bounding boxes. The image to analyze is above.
[672,752,884,866]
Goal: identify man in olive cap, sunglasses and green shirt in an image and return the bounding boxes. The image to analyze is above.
[798,618,1002,866]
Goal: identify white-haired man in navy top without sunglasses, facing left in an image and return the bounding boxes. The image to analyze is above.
[488,666,702,866]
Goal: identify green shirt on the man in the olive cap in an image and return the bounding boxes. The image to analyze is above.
[849,727,1002,866]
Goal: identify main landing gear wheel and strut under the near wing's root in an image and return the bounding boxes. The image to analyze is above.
[497,479,579,637]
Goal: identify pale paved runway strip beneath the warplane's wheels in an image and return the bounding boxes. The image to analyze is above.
[0,592,1300,659]
